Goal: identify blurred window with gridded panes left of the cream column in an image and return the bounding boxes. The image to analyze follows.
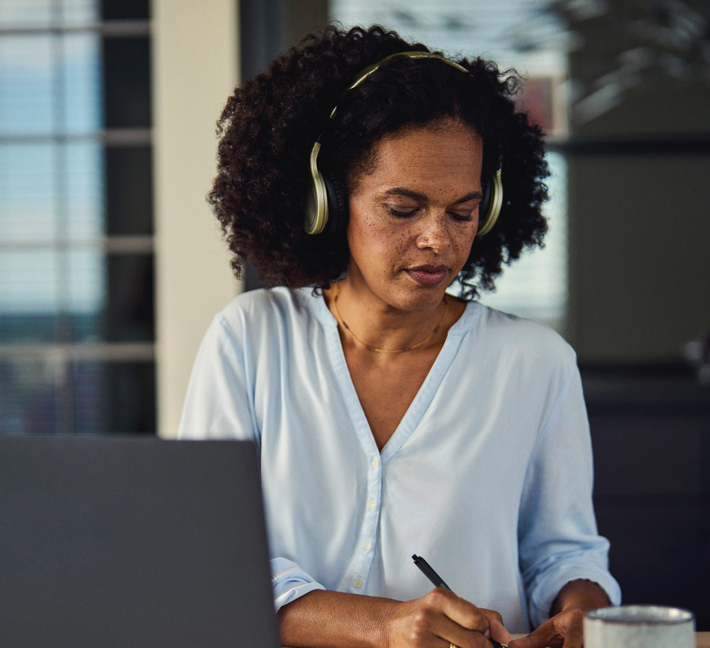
[0,0,155,433]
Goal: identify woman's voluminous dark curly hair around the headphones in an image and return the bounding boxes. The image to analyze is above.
[209,25,549,298]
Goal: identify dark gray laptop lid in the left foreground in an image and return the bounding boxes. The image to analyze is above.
[0,436,279,648]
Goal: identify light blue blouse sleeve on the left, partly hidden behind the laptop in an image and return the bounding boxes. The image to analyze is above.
[178,315,325,610]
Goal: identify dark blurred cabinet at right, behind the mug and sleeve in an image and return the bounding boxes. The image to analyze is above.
[582,367,710,631]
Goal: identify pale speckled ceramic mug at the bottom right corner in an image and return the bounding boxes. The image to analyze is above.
[584,605,695,648]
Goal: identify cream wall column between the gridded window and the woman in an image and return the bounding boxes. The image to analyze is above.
[151,0,240,437]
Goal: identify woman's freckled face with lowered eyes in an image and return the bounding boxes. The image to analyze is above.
[347,123,483,311]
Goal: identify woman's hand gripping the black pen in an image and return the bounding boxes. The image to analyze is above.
[387,587,510,648]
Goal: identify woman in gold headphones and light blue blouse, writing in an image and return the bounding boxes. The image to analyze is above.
[181,27,619,648]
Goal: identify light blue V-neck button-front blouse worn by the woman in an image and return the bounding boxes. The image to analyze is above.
[180,288,620,632]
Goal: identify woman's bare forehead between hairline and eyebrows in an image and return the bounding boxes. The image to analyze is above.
[357,124,483,191]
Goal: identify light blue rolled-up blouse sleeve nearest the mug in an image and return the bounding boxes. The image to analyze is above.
[518,364,621,627]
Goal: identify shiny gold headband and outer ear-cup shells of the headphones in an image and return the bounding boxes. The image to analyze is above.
[303,52,503,236]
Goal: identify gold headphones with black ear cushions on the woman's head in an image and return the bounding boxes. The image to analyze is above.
[304,52,503,236]
